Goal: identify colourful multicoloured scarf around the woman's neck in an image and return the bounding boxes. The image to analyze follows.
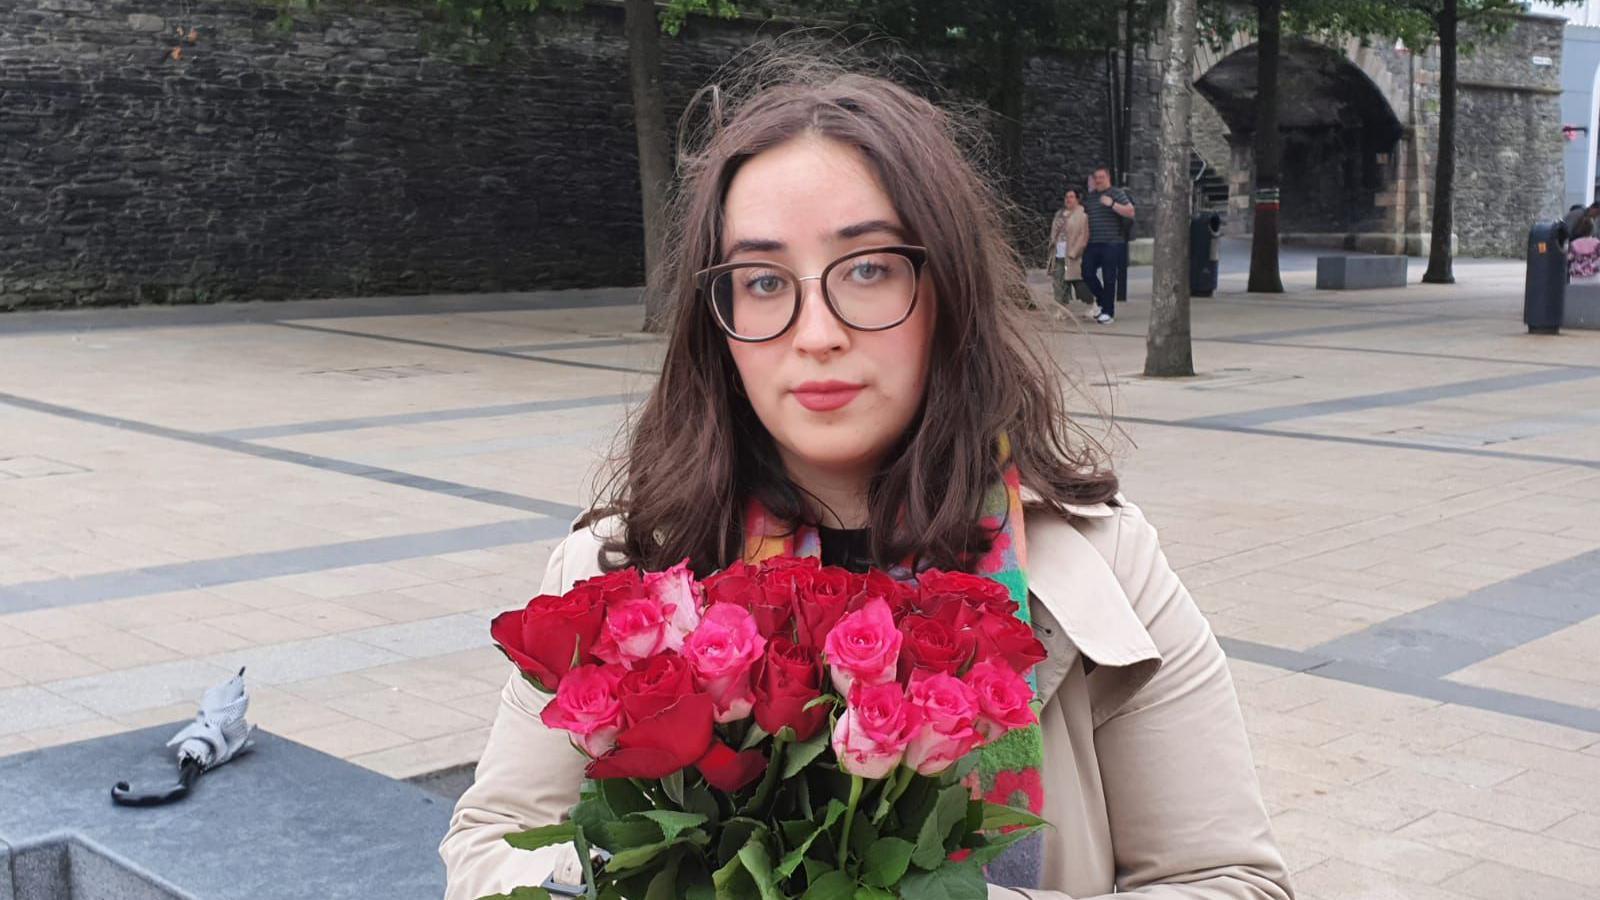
[744,439,1045,887]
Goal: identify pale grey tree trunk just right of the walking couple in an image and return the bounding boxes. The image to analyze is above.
[1144,0,1197,376]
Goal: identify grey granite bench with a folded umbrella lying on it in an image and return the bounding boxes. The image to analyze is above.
[0,722,451,900]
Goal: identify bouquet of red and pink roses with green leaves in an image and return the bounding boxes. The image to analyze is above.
[491,557,1045,900]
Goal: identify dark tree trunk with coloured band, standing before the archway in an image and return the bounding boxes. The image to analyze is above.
[1245,0,1283,293]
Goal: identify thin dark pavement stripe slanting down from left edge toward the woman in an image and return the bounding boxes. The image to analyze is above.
[0,394,579,520]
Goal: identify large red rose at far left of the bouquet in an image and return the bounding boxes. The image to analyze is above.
[490,588,605,693]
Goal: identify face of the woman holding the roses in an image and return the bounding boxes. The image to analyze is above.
[720,136,936,482]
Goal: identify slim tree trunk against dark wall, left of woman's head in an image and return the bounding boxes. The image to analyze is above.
[622,0,672,331]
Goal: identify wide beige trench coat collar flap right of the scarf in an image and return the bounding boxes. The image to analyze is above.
[1027,503,1162,724]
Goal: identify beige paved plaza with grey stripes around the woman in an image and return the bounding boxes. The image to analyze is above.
[0,242,1600,900]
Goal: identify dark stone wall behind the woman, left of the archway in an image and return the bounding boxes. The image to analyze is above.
[0,0,1155,309]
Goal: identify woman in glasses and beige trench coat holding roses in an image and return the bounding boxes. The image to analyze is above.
[440,69,1293,900]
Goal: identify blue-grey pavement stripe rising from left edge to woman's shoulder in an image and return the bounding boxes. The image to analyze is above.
[0,517,568,615]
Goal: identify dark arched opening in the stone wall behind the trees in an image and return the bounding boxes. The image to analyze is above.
[1194,34,1421,253]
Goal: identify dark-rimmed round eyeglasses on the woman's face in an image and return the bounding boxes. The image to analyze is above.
[694,245,928,343]
